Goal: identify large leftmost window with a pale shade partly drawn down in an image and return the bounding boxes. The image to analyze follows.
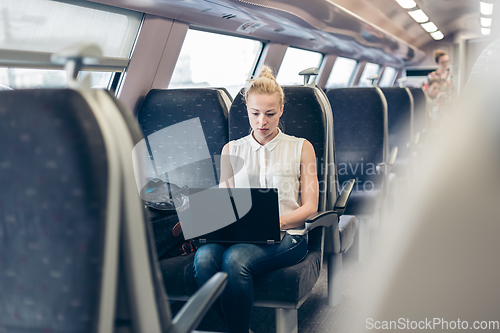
[0,0,143,89]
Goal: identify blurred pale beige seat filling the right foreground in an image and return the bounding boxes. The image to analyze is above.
[357,41,500,331]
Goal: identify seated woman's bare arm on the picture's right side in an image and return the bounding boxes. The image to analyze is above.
[280,140,319,230]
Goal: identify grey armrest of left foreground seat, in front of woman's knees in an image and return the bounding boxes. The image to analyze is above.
[171,272,227,333]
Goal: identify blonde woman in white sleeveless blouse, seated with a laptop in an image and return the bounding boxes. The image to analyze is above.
[194,66,319,333]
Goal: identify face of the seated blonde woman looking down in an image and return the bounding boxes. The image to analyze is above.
[247,94,283,145]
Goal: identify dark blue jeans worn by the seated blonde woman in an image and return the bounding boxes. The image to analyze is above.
[194,233,307,333]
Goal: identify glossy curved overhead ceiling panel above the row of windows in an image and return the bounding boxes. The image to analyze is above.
[88,0,490,66]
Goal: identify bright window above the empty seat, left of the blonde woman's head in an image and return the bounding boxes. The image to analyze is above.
[168,29,263,97]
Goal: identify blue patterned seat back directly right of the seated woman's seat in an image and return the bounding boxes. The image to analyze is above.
[326,88,386,216]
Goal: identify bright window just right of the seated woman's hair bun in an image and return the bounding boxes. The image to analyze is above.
[276,47,323,85]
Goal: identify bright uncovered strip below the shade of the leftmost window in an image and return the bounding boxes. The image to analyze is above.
[0,67,113,89]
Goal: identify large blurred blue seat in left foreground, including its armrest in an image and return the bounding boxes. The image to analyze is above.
[0,84,230,333]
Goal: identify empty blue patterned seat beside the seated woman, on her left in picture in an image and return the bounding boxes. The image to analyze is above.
[137,88,231,290]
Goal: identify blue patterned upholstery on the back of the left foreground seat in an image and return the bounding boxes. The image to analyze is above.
[0,89,108,332]
